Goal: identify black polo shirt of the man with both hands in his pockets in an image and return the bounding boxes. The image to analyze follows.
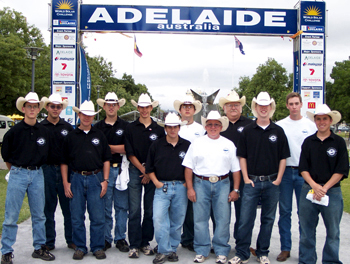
[237,121,290,176]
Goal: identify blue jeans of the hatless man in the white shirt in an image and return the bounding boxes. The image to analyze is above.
[278,167,304,251]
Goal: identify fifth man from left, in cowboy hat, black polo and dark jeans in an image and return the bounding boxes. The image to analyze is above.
[125,93,165,258]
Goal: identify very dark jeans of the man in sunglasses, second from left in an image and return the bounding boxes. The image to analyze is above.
[42,165,73,246]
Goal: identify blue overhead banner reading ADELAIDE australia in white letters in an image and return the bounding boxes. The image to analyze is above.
[80,5,297,35]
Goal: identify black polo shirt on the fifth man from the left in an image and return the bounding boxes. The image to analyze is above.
[125,119,165,163]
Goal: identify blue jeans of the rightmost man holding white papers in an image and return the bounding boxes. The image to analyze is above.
[299,183,343,264]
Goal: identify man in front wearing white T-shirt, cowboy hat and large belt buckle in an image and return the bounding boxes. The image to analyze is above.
[182,111,240,263]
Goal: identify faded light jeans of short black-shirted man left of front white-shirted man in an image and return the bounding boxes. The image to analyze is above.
[153,181,188,255]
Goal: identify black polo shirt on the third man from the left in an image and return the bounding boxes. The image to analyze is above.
[62,127,112,171]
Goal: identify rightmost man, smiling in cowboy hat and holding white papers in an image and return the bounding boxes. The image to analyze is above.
[299,104,349,264]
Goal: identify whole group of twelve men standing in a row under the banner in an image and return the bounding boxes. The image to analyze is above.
[1,88,349,264]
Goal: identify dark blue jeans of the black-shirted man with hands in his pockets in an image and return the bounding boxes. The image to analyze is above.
[236,181,279,260]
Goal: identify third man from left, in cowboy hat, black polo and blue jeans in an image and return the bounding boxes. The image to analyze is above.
[61,101,112,260]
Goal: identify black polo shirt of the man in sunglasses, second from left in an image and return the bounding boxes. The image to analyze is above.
[40,118,74,165]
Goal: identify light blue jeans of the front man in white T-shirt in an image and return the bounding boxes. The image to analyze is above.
[193,176,231,257]
